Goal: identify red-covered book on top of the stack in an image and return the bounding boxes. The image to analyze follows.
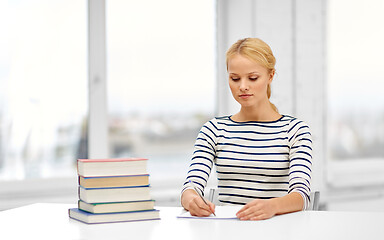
[77,158,148,177]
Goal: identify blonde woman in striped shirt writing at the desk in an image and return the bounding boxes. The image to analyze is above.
[181,38,312,220]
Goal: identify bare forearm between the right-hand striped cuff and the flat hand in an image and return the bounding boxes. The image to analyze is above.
[271,192,304,215]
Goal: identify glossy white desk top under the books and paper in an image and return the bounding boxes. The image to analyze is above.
[0,203,384,240]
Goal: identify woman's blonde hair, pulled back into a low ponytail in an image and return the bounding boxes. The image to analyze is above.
[226,38,278,112]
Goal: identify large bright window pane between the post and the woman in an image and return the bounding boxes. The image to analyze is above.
[107,0,215,203]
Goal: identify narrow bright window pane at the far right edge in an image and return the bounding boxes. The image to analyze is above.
[328,0,384,160]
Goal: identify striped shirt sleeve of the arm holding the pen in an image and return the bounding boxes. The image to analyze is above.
[182,119,217,197]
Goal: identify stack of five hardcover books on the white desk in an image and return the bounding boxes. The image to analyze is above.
[69,158,160,223]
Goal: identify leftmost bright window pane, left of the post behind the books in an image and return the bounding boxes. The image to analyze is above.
[0,0,87,180]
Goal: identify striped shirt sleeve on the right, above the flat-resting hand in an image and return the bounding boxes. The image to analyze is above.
[288,119,312,209]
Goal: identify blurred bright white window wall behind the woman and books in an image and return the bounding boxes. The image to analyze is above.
[0,0,384,211]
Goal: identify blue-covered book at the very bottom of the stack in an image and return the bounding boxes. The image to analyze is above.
[68,208,160,224]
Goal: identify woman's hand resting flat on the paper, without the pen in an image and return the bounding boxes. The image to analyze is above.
[236,199,277,220]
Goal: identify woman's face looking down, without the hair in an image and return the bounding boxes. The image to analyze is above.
[228,54,274,107]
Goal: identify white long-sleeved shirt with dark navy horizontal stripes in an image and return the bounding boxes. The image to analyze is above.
[183,115,312,209]
